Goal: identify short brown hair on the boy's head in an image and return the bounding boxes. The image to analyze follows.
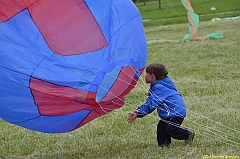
[146,62,168,80]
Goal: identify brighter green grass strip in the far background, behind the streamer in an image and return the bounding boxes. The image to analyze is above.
[136,0,240,27]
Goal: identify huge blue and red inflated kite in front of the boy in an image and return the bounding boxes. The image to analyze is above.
[0,0,147,133]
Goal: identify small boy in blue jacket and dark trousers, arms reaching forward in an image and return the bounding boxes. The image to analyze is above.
[128,63,195,147]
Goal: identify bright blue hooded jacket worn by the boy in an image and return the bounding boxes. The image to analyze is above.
[137,77,186,119]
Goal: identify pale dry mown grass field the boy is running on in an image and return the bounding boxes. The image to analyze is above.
[0,0,240,159]
